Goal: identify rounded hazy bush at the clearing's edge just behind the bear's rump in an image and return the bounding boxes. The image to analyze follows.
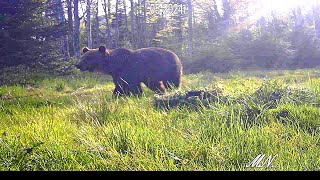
[185,32,296,73]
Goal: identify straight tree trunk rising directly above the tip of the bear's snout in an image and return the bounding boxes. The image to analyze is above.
[73,0,80,61]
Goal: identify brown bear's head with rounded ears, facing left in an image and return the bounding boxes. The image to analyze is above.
[75,46,110,73]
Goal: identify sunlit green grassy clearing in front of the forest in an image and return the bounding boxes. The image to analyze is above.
[0,69,320,171]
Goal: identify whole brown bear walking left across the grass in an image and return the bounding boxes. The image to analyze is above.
[76,46,182,96]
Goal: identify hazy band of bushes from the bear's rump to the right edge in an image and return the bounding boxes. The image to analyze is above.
[184,26,320,73]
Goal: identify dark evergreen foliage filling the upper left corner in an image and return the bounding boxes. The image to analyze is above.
[0,0,65,69]
